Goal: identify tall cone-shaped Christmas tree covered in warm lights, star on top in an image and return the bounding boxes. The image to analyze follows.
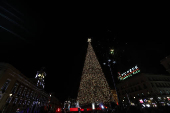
[77,39,111,106]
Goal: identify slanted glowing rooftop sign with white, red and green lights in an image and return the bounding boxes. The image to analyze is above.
[118,65,140,80]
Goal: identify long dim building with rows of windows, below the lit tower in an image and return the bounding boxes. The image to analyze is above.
[0,63,58,113]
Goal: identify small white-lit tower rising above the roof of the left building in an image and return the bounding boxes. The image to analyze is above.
[35,68,46,89]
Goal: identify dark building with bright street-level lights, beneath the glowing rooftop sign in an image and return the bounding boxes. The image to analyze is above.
[117,73,170,107]
